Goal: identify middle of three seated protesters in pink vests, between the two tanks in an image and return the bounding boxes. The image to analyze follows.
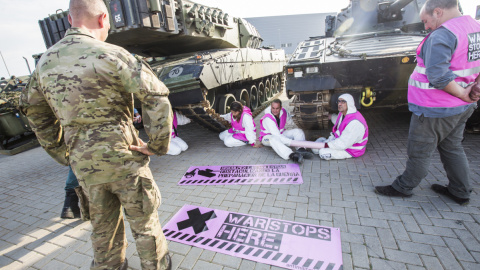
[259,99,312,163]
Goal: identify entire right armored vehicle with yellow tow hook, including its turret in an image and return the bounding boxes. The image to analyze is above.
[286,0,427,130]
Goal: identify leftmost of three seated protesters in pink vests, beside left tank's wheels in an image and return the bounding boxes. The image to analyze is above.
[219,101,257,147]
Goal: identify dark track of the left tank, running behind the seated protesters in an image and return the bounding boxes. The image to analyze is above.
[179,78,285,132]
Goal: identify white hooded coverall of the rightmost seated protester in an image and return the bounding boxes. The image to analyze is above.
[312,94,365,160]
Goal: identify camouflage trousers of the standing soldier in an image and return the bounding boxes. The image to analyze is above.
[81,176,168,270]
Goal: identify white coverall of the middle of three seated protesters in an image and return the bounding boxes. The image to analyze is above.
[262,107,305,160]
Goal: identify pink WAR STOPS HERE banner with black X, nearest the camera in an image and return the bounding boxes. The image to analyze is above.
[163,205,343,270]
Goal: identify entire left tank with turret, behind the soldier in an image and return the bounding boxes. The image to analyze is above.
[39,0,286,131]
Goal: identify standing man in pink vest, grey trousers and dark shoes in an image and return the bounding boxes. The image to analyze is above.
[375,0,480,205]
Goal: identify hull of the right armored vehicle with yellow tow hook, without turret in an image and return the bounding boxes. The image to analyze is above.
[286,31,424,130]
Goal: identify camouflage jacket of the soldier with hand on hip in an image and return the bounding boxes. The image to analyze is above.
[20,28,173,185]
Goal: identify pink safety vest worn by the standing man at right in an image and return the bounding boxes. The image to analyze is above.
[408,16,480,108]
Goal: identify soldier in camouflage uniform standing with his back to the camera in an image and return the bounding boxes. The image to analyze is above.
[21,0,173,269]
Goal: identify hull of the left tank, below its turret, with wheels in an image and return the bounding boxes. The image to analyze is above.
[151,48,285,131]
